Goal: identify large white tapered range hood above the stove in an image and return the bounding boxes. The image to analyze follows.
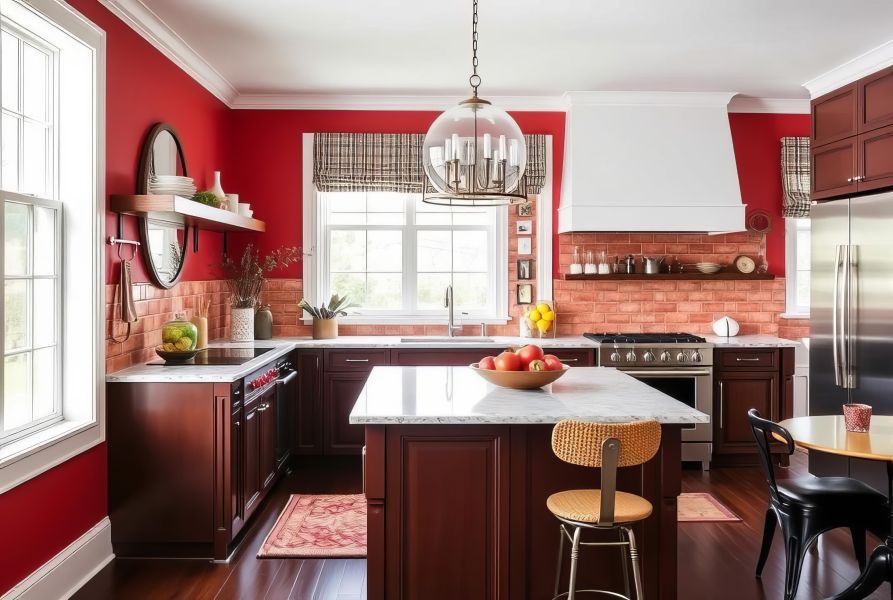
[558,92,744,233]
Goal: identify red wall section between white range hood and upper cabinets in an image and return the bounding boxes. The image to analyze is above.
[729,113,810,277]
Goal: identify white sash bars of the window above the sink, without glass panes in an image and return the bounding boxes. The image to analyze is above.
[314,192,508,321]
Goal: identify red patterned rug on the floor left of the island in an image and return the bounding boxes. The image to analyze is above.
[257,494,366,558]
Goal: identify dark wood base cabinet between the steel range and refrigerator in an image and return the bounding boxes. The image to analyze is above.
[712,348,794,466]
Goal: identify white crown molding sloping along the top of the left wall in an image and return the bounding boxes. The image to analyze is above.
[99,0,238,106]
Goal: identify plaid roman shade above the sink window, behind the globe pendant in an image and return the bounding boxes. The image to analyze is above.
[313,133,546,194]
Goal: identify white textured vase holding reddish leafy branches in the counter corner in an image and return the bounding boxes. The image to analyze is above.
[223,244,302,342]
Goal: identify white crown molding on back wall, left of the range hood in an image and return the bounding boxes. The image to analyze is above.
[230,94,565,111]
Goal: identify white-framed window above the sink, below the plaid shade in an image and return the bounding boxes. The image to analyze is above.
[313,192,507,321]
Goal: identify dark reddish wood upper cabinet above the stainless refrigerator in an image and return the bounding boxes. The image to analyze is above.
[810,67,893,200]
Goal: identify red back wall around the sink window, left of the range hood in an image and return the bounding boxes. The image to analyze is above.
[224,110,565,277]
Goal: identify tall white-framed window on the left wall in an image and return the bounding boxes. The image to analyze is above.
[0,0,105,493]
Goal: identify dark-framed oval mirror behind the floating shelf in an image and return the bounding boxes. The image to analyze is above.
[137,123,189,288]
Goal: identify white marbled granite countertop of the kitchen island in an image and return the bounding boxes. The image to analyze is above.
[350,367,710,425]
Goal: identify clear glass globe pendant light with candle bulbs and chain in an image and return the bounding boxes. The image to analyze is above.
[422,0,527,206]
